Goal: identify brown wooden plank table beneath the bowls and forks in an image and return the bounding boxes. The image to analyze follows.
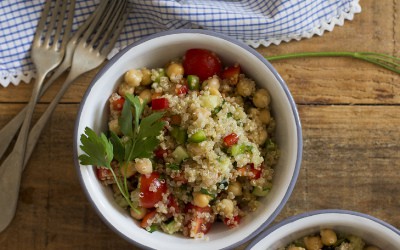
[0,0,400,249]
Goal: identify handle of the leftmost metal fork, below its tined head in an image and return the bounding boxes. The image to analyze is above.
[0,72,48,232]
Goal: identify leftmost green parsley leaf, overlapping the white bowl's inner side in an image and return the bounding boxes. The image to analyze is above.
[79,127,114,168]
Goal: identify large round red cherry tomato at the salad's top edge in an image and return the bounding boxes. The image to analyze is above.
[182,49,222,81]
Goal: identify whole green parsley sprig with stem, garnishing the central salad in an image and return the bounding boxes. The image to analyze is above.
[79,94,164,210]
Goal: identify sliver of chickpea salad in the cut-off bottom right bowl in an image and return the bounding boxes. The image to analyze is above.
[277,228,381,250]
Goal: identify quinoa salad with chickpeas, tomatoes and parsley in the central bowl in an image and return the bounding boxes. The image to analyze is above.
[79,48,279,238]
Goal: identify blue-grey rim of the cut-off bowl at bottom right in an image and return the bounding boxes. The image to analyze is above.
[245,209,400,250]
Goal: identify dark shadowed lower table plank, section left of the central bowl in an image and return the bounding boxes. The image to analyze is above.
[0,104,134,249]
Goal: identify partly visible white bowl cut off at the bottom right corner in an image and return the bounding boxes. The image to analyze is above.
[246,209,400,250]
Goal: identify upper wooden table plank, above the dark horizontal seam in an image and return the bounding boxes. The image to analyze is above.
[0,0,400,104]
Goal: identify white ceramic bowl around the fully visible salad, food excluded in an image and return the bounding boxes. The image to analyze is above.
[74,30,302,250]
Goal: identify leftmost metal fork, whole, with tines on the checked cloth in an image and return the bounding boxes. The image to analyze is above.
[0,0,75,232]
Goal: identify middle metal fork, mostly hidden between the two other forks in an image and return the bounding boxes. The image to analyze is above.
[0,1,108,162]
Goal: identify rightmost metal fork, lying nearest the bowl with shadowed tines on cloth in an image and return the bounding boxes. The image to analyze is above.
[0,0,127,231]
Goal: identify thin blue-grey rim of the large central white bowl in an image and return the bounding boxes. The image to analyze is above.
[73,29,303,248]
